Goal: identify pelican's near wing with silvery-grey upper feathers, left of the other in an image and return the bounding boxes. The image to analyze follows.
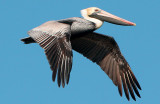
[28,21,72,87]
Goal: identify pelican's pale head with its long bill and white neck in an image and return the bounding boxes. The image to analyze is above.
[81,7,136,28]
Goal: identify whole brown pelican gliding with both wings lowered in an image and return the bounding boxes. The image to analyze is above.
[21,7,141,100]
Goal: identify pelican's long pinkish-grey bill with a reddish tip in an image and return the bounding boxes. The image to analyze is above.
[90,10,136,26]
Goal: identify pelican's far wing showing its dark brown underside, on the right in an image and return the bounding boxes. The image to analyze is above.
[71,32,141,100]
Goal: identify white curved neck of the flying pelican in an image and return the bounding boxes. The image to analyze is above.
[81,10,103,29]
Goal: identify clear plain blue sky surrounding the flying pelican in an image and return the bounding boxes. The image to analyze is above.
[0,0,160,104]
